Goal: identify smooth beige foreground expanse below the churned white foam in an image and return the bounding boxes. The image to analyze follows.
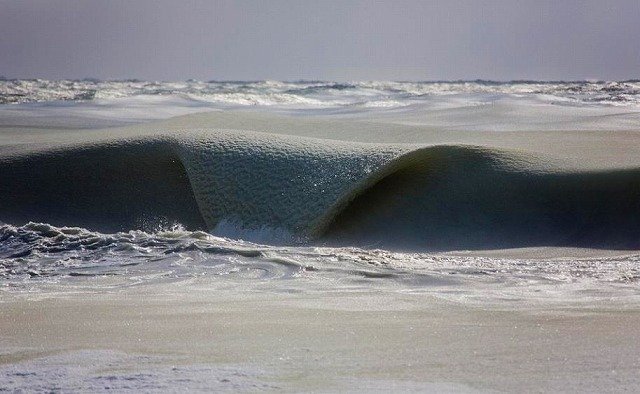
[0,284,640,392]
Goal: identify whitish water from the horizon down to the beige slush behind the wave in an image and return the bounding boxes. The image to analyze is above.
[0,80,640,131]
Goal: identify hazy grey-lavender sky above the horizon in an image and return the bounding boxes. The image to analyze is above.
[0,0,640,80]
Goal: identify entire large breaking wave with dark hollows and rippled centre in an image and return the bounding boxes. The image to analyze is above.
[0,130,640,251]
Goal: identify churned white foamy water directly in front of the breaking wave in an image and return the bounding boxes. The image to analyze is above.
[0,223,640,305]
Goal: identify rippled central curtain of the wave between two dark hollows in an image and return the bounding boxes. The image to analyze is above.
[174,130,404,237]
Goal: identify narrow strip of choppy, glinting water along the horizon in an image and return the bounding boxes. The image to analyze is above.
[0,79,640,110]
